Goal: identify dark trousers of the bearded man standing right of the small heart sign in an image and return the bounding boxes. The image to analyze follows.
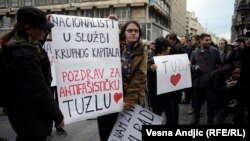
[194,88,215,124]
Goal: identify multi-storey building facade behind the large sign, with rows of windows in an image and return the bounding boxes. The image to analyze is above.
[0,0,178,42]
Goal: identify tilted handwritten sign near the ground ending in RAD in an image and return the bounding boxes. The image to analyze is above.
[108,105,162,141]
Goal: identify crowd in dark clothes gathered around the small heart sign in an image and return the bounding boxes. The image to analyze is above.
[147,32,250,125]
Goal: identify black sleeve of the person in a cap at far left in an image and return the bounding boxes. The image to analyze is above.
[8,55,63,124]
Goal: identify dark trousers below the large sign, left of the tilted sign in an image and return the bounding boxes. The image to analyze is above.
[97,113,118,141]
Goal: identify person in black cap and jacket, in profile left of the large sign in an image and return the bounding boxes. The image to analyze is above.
[1,6,64,141]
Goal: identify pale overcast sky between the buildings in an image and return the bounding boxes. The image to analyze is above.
[187,0,235,39]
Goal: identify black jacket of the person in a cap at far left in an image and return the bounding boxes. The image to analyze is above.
[4,40,63,136]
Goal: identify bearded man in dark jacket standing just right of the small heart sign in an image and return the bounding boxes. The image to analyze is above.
[190,33,222,124]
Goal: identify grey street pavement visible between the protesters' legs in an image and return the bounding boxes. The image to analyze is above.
[0,104,232,141]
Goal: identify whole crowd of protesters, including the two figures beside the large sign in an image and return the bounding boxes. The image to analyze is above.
[1,7,250,141]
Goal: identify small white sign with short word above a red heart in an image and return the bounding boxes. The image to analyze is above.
[154,54,192,94]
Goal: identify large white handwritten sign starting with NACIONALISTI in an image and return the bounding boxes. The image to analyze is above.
[51,15,123,123]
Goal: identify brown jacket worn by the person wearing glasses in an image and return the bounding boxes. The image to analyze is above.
[120,41,147,105]
